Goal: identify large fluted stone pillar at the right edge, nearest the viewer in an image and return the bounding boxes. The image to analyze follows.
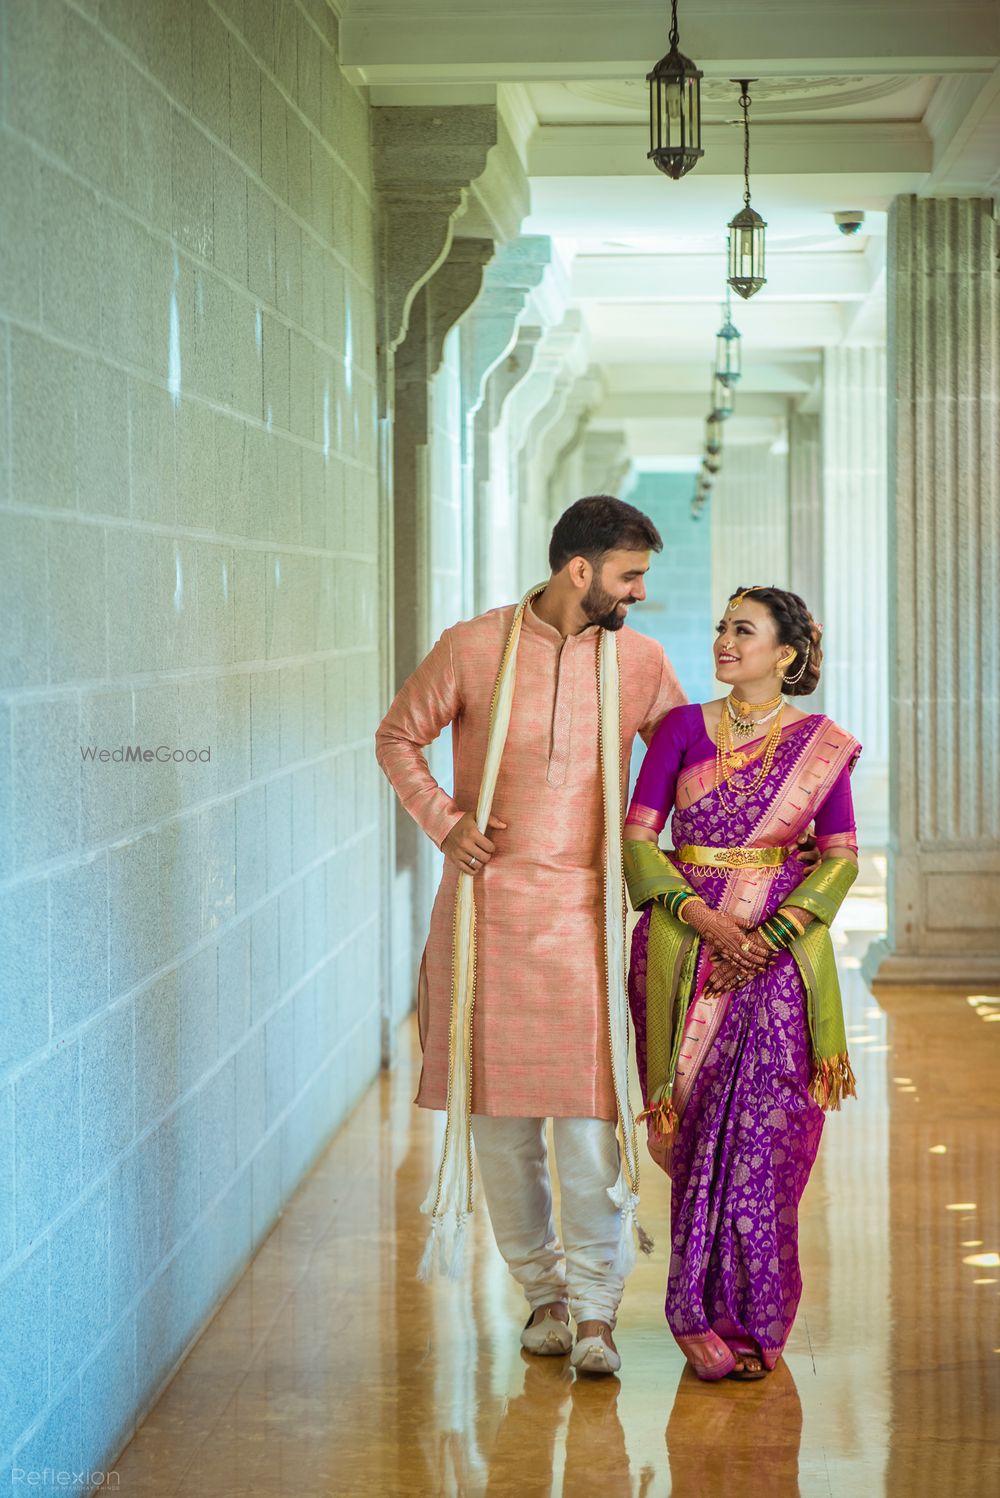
[865,198,1000,992]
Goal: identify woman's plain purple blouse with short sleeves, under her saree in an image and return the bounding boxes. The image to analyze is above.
[626,703,856,852]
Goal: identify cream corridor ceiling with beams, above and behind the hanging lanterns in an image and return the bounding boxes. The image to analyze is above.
[341,0,1000,466]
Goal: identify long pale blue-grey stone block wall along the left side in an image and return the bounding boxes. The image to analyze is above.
[0,0,380,1471]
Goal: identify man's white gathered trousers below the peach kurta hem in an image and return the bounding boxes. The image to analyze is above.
[472,1113,624,1327]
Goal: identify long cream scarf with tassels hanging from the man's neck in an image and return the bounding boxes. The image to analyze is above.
[418,583,643,1279]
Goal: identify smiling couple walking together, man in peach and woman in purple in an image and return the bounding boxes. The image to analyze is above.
[376,494,859,1378]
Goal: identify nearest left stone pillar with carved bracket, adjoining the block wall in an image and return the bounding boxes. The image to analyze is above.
[371,103,528,1064]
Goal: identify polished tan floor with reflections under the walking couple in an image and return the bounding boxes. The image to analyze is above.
[103,894,1000,1498]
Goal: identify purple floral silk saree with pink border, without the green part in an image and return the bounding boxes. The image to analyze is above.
[629,718,858,1368]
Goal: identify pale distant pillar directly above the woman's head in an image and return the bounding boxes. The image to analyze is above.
[706,442,789,619]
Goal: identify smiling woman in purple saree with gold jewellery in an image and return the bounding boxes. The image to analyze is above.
[624,586,861,1380]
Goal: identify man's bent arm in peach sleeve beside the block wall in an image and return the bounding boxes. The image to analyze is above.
[376,629,463,848]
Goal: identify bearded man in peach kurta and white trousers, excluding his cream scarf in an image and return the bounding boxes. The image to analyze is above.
[376,494,686,1372]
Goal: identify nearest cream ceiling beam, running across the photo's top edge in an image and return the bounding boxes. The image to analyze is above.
[340,0,1000,84]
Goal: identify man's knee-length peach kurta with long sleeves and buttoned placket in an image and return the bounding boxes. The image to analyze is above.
[376,605,686,1119]
